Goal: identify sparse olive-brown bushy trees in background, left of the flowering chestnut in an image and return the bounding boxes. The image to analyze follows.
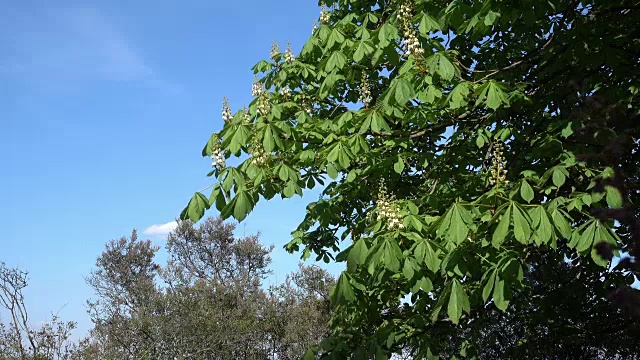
[80,218,333,360]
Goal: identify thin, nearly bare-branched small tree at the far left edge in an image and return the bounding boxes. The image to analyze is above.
[0,262,76,360]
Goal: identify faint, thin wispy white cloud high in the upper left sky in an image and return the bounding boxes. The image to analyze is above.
[0,7,175,90]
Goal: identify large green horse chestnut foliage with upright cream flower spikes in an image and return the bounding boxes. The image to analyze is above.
[181,0,640,359]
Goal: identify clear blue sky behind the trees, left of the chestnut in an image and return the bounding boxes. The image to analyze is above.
[0,0,337,336]
